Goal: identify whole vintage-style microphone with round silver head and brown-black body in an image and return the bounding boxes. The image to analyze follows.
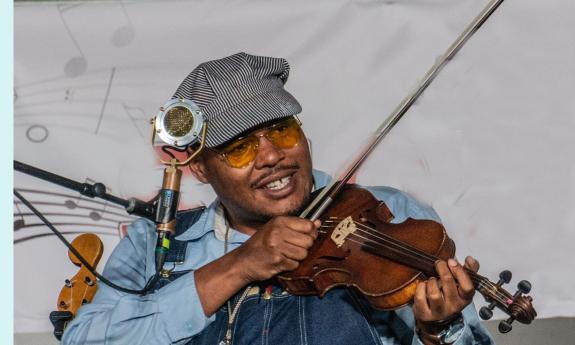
[151,98,207,272]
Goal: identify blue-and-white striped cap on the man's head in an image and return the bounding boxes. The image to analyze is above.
[172,53,301,147]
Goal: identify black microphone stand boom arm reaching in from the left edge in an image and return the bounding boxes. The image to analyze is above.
[14,160,157,221]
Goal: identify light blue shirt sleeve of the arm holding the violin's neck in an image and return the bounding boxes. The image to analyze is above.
[367,187,495,345]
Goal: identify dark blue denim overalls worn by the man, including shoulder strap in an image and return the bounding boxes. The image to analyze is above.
[158,209,413,345]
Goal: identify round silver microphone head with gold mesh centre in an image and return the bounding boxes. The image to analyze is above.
[154,98,205,148]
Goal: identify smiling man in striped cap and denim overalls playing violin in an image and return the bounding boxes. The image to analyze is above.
[63,53,493,345]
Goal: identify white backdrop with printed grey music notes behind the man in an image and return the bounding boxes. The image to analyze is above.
[14,0,575,332]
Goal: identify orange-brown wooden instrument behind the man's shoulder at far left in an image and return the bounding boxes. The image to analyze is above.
[50,233,104,340]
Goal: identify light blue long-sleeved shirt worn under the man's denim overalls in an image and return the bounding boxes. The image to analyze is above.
[62,171,493,345]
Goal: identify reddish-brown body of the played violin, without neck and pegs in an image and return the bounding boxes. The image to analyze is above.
[278,186,455,310]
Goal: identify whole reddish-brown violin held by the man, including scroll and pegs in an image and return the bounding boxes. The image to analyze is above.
[278,185,537,333]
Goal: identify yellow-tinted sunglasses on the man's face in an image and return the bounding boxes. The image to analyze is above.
[210,117,302,169]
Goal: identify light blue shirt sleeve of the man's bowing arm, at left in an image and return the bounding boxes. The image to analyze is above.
[62,219,215,345]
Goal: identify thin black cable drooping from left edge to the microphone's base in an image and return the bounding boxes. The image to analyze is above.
[14,189,161,295]
